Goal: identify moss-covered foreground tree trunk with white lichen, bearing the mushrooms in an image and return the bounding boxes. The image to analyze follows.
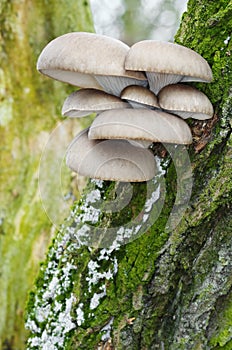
[27,0,232,350]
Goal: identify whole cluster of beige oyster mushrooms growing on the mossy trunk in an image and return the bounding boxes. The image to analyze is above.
[37,32,213,182]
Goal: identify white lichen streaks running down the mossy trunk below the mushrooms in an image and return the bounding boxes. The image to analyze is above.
[27,174,165,350]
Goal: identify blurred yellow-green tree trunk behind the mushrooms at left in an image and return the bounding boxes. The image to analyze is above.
[0,0,93,350]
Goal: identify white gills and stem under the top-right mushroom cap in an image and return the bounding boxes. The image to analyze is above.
[146,72,183,95]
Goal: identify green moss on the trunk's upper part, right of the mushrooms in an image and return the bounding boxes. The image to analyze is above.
[175,0,232,107]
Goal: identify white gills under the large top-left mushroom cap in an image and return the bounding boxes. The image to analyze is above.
[95,75,147,96]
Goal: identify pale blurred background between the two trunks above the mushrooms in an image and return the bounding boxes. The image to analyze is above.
[90,0,188,45]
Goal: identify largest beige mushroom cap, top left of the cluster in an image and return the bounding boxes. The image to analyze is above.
[37,32,146,89]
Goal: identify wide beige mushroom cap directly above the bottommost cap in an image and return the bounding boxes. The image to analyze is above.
[88,109,192,144]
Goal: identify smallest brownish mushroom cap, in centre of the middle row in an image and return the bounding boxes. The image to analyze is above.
[121,85,160,108]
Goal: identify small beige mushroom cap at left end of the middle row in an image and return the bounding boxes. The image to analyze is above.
[62,89,130,117]
